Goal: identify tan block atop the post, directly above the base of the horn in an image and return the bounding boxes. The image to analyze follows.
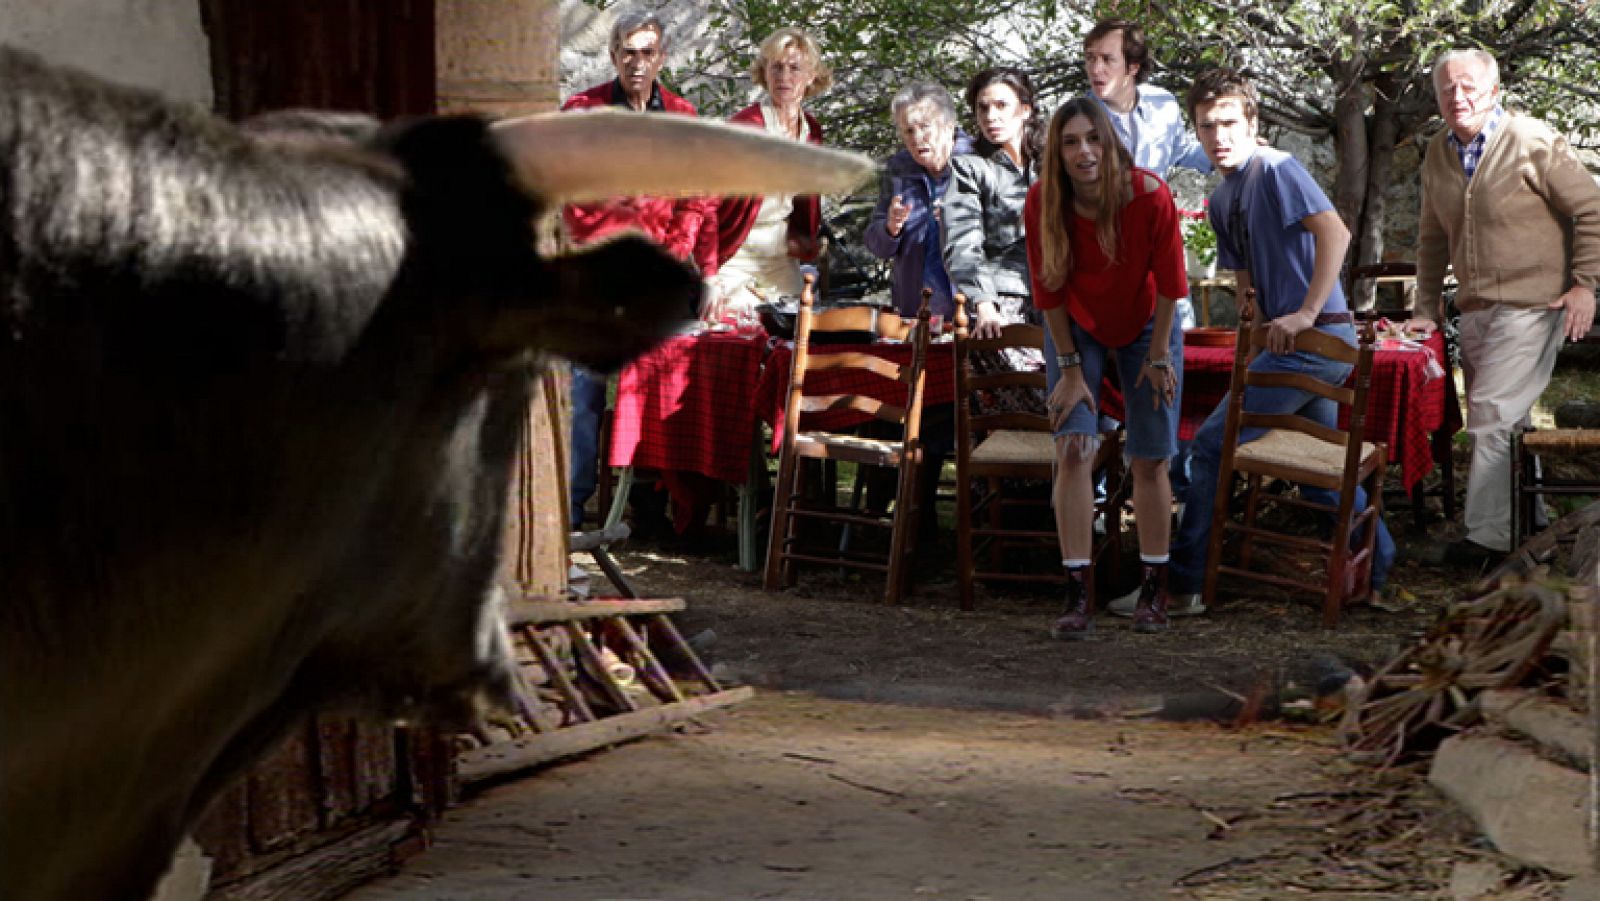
[434,0,562,115]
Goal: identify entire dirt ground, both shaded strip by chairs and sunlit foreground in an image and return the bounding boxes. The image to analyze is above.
[340,356,1600,901]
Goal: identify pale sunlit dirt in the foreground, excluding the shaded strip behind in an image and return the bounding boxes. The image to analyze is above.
[350,691,1491,901]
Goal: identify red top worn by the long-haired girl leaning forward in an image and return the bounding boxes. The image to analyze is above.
[1022,168,1189,347]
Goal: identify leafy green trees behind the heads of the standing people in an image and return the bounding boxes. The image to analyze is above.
[668,0,1600,259]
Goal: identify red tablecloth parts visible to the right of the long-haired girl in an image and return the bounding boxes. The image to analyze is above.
[1102,333,1461,493]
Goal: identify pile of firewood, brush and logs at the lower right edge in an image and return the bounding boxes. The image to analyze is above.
[1341,504,1600,875]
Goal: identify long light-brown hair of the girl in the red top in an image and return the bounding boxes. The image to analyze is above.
[1038,94,1133,291]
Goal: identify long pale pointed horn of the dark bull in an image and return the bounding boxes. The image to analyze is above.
[494,110,874,202]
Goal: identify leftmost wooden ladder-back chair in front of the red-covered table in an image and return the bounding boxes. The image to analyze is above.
[765,277,928,603]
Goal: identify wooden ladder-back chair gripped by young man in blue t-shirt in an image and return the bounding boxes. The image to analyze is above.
[1205,302,1387,629]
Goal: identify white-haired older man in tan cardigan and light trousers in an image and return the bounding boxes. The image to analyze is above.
[1413,50,1600,565]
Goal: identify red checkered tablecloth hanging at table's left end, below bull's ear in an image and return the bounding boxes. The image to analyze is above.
[608,334,768,483]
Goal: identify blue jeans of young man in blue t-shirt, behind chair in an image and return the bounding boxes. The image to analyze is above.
[1166,325,1395,594]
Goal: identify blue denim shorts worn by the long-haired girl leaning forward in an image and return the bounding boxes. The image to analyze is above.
[1045,320,1184,459]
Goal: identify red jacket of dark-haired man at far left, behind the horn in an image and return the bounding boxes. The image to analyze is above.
[562,82,720,277]
